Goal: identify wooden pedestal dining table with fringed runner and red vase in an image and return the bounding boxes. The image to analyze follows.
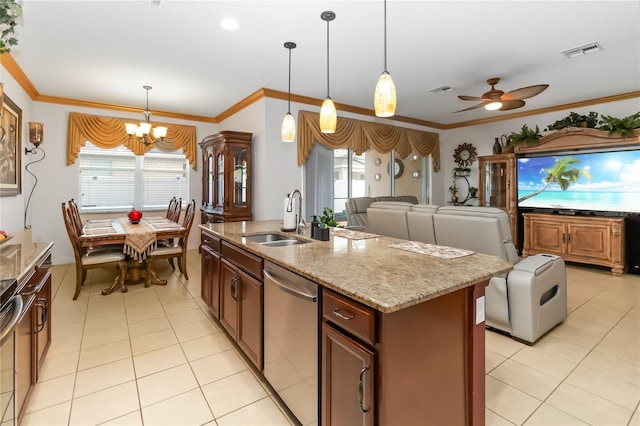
[79,216,185,295]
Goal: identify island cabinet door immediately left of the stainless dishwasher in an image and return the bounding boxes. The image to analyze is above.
[238,270,264,371]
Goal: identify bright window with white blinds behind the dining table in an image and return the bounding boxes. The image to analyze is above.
[78,142,189,212]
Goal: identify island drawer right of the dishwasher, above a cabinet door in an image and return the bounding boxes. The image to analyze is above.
[322,290,376,345]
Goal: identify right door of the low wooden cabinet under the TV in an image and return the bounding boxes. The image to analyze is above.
[567,223,612,260]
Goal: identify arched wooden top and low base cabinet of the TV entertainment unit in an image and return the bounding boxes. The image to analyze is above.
[515,127,640,276]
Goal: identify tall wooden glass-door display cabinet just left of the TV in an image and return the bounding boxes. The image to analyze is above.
[478,154,519,247]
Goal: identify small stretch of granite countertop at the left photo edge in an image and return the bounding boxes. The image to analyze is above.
[0,232,53,284]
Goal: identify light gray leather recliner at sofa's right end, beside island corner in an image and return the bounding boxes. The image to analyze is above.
[433,207,567,344]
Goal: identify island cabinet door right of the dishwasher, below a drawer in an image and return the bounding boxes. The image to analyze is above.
[322,323,375,426]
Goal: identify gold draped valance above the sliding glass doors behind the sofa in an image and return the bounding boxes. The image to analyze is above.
[298,111,440,172]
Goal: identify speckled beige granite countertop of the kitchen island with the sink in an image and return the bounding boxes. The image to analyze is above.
[200,220,512,313]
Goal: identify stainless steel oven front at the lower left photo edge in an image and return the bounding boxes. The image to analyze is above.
[0,280,22,425]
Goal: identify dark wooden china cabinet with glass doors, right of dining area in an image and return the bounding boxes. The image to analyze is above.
[200,131,252,223]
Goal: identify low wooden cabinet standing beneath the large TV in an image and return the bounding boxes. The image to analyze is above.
[522,213,624,276]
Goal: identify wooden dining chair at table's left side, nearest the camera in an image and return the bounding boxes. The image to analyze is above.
[62,203,127,300]
